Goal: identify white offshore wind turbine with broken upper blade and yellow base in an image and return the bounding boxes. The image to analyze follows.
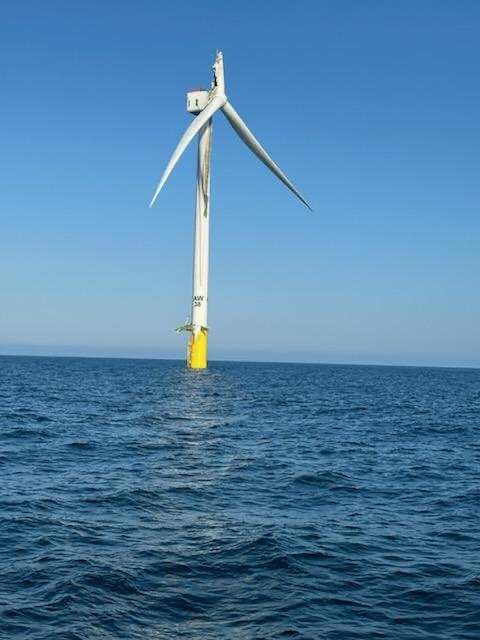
[150,51,311,369]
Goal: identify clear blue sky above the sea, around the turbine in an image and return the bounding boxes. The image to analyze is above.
[0,0,480,366]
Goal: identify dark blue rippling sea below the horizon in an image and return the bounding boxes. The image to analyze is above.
[0,357,480,640]
